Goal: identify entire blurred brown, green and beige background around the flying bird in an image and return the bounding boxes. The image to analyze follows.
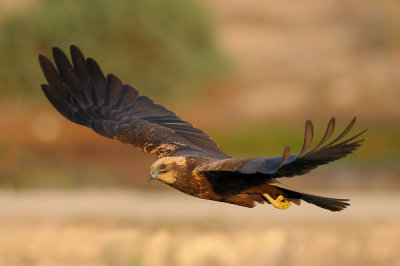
[0,0,400,265]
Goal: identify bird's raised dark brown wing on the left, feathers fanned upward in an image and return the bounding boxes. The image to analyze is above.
[39,45,229,158]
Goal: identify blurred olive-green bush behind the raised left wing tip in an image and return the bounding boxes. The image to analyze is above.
[0,0,224,97]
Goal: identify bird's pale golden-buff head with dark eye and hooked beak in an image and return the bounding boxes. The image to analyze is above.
[148,156,186,184]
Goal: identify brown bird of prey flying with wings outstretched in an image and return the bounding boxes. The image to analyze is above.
[39,45,364,211]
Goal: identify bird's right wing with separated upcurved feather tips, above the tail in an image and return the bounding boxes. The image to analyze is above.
[198,118,366,178]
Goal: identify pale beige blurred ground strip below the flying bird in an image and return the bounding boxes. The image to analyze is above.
[0,190,400,266]
